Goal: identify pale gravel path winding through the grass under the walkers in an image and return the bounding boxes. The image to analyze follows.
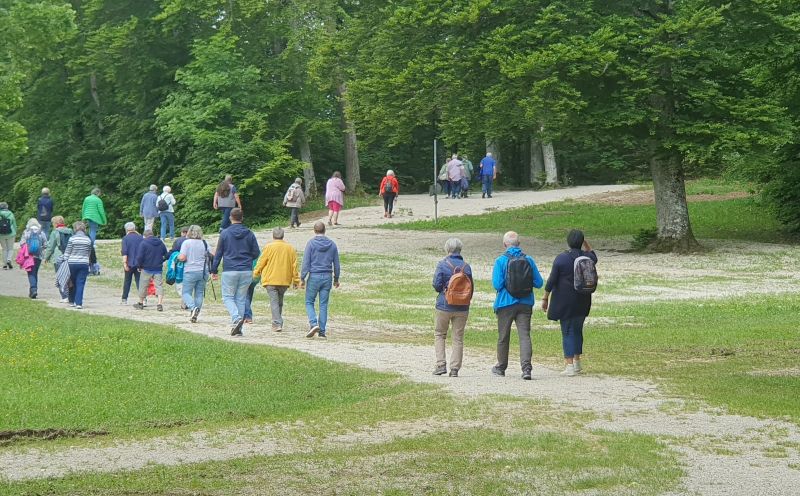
[0,184,800,495]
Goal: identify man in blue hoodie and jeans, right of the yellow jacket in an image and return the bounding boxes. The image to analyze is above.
[300,221,339,338]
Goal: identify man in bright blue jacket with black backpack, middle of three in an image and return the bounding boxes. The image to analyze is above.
[492,231,544,381]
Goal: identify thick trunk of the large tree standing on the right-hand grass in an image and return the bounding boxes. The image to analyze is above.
[650,155,700,253]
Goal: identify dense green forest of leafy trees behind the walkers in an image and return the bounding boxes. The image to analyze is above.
[0,0,800,251]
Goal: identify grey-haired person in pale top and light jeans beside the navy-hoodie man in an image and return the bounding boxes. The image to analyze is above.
[178,225,211,323]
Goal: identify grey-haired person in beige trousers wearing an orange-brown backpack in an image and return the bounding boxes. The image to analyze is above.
[433,238,474,377]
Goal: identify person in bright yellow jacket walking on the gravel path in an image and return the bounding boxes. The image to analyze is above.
[253,227,300,332]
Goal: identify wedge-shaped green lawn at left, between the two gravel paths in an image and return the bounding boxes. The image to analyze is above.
[0,297,450,440]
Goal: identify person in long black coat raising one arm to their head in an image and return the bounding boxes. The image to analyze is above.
[542,229,597,377]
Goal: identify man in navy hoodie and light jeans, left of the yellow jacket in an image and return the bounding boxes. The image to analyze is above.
[211,208,261,336]
